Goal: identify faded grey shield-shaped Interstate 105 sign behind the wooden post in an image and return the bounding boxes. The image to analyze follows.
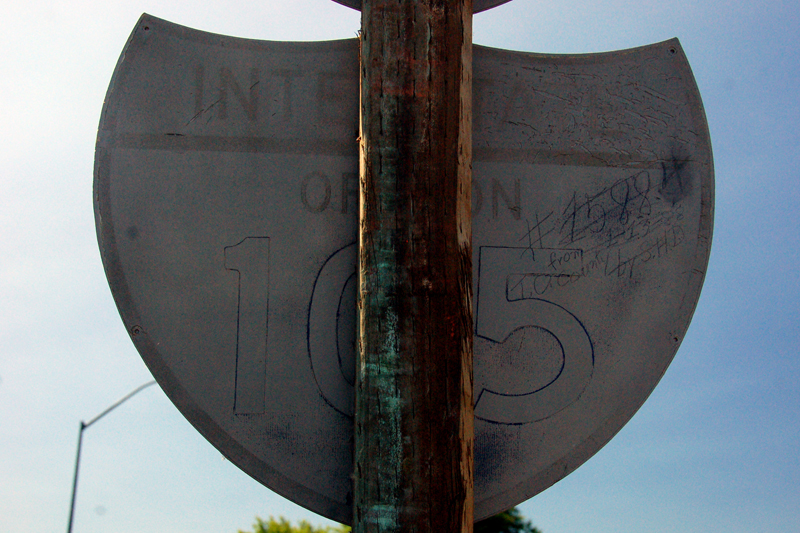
[95,15,713,522]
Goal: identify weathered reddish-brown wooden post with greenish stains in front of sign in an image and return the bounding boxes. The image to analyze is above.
[354,0,473,533]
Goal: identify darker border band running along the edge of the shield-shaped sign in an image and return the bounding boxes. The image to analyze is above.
[94,15,714,523]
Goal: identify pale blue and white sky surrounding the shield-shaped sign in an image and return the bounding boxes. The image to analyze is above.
[0,0,800,533]
